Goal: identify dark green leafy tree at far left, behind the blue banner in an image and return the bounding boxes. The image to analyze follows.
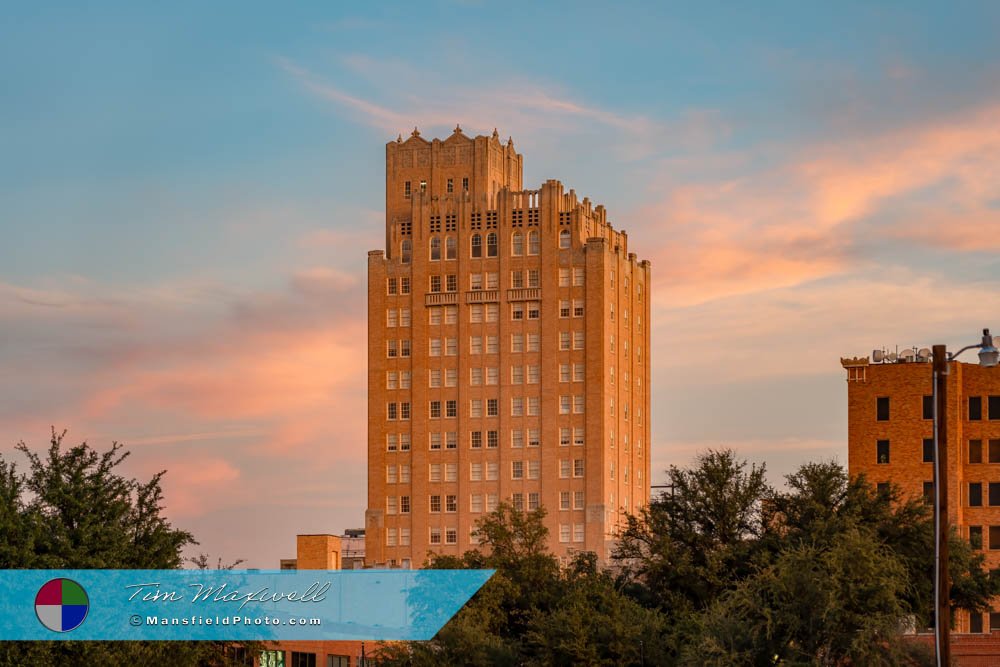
[0,429,249,667]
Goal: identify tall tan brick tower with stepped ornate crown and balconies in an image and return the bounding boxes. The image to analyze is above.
[365,127,650,567]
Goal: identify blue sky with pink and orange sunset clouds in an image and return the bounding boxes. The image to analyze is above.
[0,2,1000,566]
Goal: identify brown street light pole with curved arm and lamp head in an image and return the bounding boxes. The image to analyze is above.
[932,329,1000,667]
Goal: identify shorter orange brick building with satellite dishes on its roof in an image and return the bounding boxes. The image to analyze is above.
[840,354,1000,633]
